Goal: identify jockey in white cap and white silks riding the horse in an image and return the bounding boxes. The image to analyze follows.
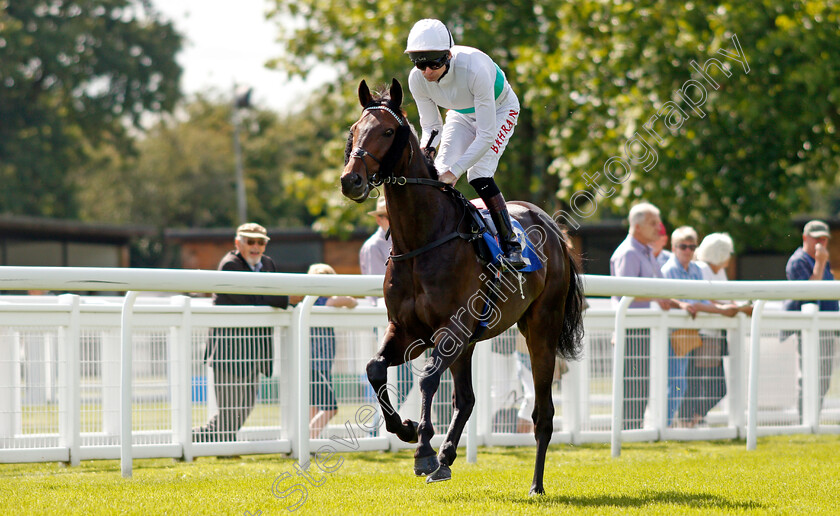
[405,19,525,269]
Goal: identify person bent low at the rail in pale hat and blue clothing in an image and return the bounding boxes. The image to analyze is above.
[307,263,357,439]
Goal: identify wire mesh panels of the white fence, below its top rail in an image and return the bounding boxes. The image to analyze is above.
[0,305,840,460]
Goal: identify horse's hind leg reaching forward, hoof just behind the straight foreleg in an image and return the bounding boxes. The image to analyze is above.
[426,346,475,482]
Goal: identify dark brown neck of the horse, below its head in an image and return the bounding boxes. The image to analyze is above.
[385,145,458,254]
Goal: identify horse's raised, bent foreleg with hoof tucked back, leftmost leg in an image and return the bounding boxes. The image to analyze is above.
[367,324,422,443]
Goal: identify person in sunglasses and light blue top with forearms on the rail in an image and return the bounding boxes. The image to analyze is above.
[662,226,737,425]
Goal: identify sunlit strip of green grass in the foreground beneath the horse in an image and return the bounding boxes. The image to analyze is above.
[0,435,840,516]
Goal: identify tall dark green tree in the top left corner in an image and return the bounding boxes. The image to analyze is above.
[0,0,181,218]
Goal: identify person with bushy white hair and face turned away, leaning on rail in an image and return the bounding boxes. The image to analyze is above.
[680,233,752,428]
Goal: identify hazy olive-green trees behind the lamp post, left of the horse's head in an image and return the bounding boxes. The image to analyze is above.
[73,89,378,239]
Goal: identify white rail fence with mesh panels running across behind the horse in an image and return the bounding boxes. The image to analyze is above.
[0,267,840,476]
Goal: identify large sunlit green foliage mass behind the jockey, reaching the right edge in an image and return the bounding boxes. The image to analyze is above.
[268,0,840,249]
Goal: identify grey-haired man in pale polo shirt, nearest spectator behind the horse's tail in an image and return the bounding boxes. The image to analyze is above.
[610,203,671,429]
